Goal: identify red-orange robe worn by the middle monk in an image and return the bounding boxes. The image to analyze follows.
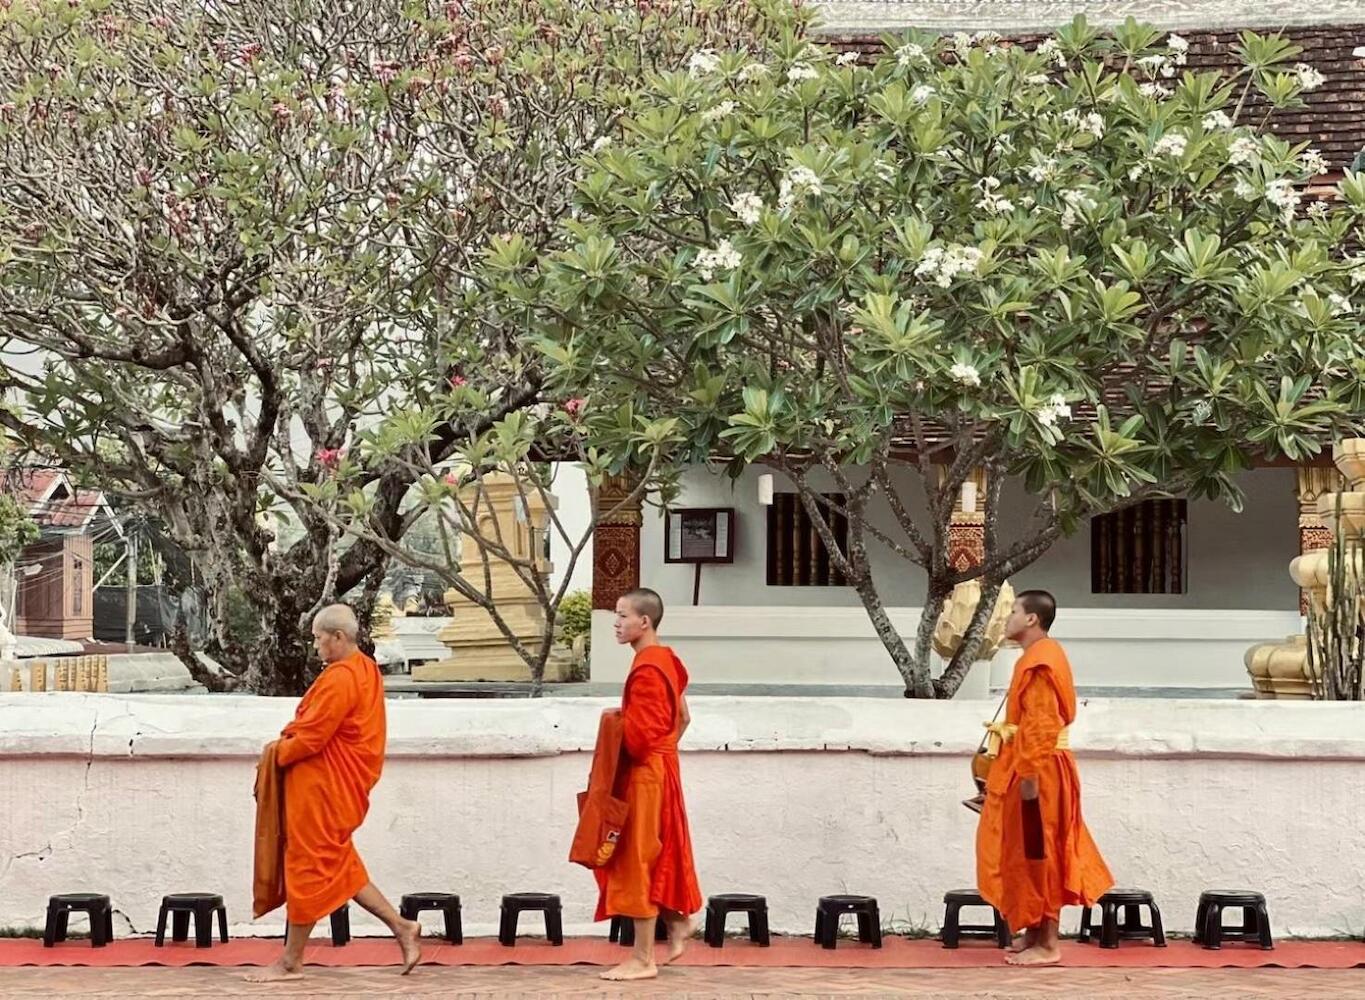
[594,645,702,920]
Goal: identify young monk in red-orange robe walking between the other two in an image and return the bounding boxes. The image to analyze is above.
[595,588,702,980]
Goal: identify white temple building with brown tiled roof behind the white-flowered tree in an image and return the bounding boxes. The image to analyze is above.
[592,0,1365,696]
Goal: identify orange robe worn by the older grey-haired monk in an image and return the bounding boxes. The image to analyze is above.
[276,651,385,924]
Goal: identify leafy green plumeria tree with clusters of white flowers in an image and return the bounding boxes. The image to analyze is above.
[499,19,1365,697]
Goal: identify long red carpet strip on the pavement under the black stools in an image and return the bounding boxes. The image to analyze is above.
[0,937,1365,969]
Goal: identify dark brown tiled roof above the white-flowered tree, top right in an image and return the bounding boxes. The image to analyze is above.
[826,22,1365,172]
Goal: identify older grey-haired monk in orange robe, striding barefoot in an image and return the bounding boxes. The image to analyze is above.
[247,604,422,982]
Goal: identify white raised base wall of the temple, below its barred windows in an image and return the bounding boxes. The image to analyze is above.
[592,607,1301,697]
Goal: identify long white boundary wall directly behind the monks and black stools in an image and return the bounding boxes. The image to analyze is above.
[0,693,1365,935]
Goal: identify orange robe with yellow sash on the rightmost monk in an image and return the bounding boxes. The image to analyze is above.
[976,638,1114,930]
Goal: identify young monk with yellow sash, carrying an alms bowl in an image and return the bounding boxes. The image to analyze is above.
[976,591,1114,966]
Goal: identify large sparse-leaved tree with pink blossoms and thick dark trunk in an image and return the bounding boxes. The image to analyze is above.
[0,0,791,693]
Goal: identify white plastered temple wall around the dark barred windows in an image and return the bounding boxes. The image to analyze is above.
[608,468,1301,694]
